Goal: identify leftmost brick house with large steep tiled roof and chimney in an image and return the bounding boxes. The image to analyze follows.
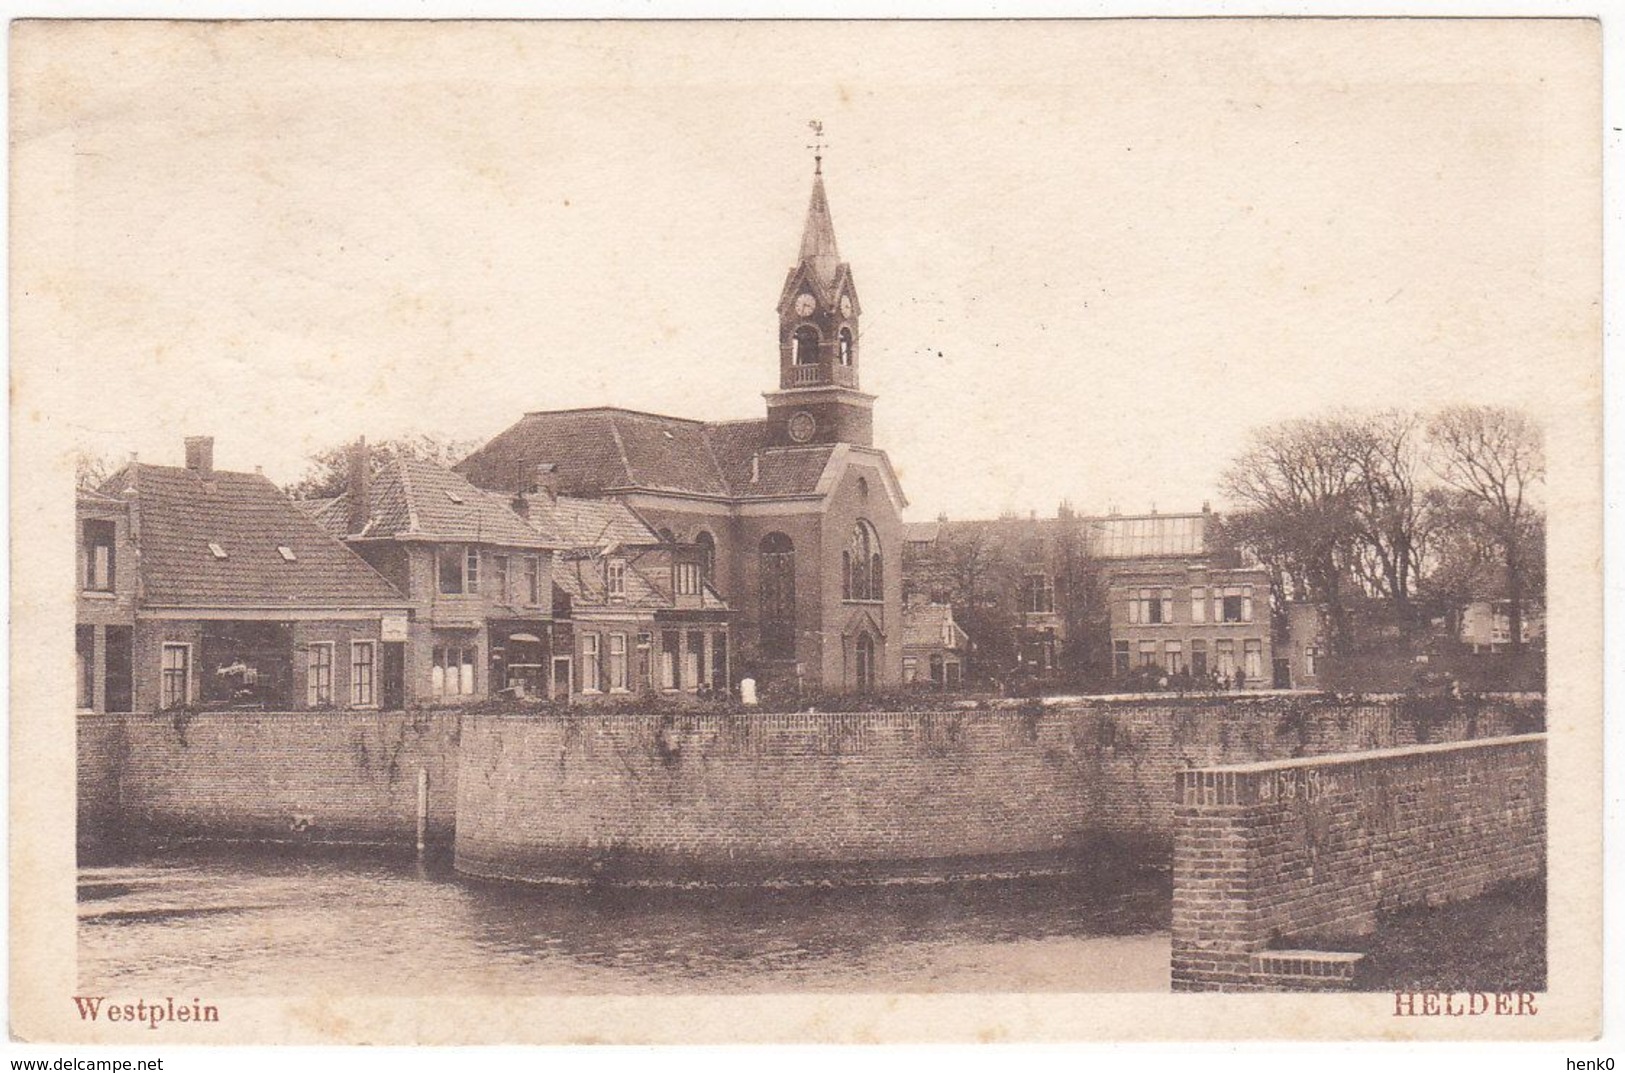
[91,437,411,712]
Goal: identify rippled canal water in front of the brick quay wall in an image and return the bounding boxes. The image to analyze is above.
[78,850,1170,997]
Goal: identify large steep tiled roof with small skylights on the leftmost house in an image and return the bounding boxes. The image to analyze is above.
[101,463,403,608]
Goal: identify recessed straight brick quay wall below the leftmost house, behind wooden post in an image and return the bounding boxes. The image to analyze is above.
[112,712,458,844]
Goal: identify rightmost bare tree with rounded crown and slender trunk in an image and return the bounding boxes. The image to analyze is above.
[1427,406,1545,652]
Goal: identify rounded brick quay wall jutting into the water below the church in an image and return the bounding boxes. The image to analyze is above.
[457,697,1528,878]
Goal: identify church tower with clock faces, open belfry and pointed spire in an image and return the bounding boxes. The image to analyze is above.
[767,153,874,447]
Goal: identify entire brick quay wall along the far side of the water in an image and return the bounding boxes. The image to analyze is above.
[78,694,1544,878]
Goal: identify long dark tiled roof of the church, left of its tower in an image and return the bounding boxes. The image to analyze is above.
[457,408,834,499]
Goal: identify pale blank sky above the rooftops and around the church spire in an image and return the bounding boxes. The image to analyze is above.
[11,21,1601,519]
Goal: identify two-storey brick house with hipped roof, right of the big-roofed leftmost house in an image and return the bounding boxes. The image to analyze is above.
[309,444,569,704]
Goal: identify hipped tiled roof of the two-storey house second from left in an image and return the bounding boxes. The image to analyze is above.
[306,458,564,548]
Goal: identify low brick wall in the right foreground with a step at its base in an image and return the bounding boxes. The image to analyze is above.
[1173,735,1545,990]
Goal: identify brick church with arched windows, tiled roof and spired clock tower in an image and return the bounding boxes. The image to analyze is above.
[457,158,907,693]
